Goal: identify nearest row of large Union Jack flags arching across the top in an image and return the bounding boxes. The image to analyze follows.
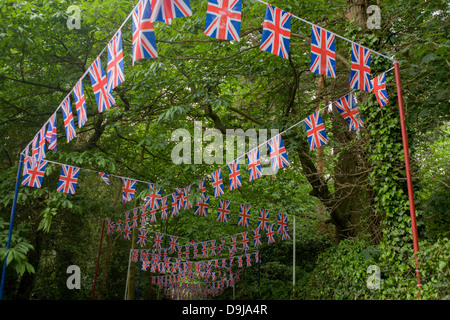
[23,0,388,166]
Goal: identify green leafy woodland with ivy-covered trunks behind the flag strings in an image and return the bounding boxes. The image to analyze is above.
[0,0,450,300]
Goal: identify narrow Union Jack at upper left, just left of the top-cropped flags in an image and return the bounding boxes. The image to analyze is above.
[133,0,158,65]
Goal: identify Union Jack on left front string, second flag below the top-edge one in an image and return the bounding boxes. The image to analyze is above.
[89,56,116,113]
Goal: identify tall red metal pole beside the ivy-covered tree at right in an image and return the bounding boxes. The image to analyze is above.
[394,60,422,299]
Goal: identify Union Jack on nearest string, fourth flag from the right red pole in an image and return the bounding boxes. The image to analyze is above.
[259,4,291,59]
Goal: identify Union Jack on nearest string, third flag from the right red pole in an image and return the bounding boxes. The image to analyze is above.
[310,26,336,78]
